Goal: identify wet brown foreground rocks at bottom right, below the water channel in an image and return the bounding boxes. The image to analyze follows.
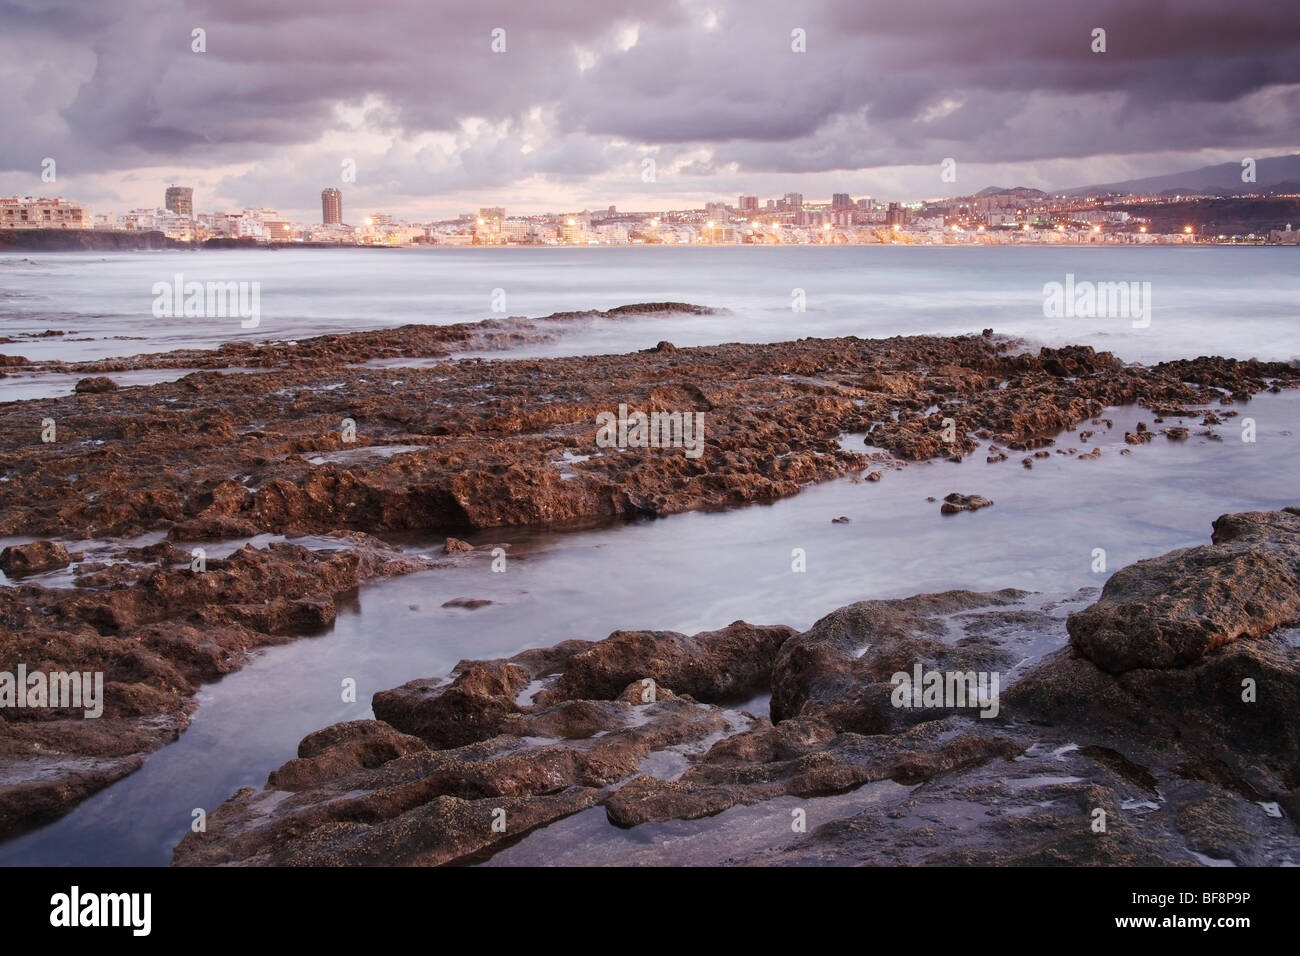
[173,510,1300,865]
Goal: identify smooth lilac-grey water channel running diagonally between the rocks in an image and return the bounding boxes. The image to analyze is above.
[0,392,1300,865]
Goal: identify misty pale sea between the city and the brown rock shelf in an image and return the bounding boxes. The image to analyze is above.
[0,246,1300,371]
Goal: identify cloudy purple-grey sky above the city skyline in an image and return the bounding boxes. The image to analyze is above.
[0,0,1300,221]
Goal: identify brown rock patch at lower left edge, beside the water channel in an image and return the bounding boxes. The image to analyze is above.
[0,533,428,835]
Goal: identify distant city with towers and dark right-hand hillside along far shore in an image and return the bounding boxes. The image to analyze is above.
[0,185,1300,246]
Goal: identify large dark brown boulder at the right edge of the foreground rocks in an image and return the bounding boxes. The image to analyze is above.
[1008,509,1300,821]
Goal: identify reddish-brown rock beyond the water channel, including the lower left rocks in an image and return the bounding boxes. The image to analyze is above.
[0,312,1300,853]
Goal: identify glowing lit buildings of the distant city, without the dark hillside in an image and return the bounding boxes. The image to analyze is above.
[15,180,1291,246]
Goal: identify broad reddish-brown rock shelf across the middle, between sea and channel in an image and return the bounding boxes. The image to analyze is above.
[0,323,1300,540]
